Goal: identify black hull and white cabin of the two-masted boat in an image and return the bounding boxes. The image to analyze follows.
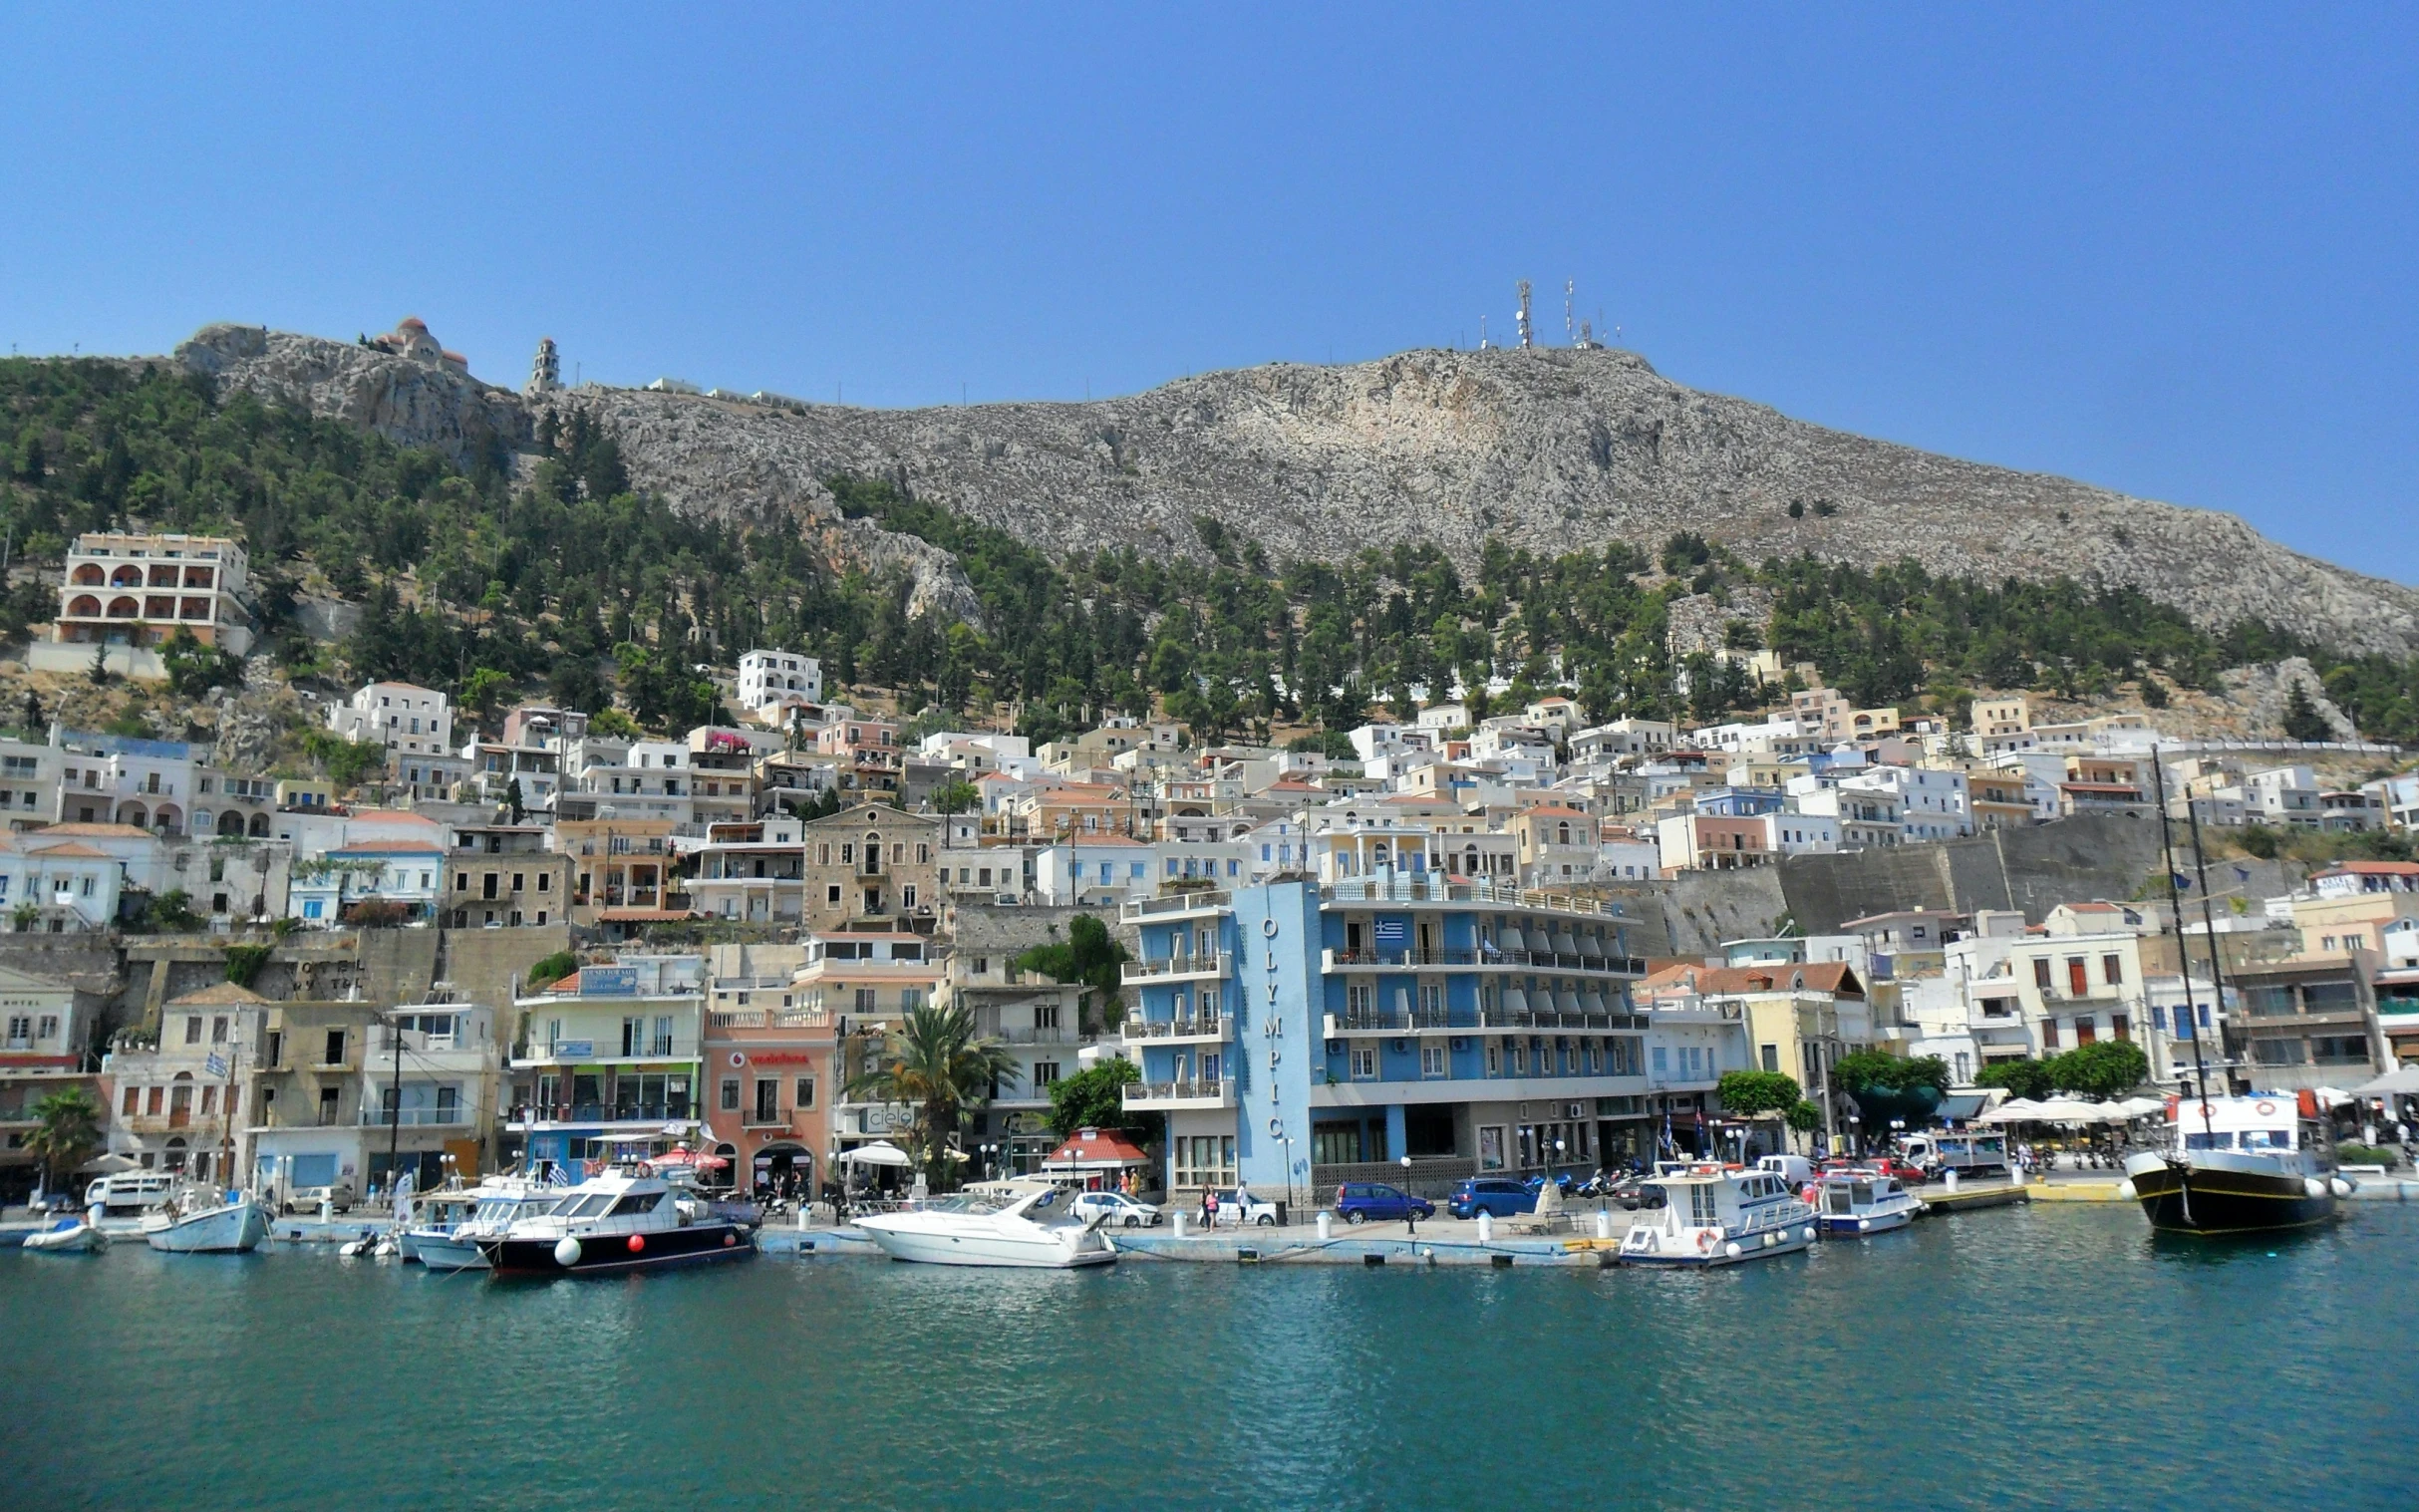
[2117,1091,2351,1234]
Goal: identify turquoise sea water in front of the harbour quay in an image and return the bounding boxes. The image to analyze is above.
[0,1205,2419,1512]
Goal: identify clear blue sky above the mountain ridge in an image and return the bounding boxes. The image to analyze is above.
[0,5,2419,581]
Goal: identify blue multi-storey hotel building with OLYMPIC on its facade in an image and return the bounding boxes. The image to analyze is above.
[1122,822,1650,1202]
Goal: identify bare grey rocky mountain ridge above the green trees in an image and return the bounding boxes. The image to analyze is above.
[179,327,2419,653]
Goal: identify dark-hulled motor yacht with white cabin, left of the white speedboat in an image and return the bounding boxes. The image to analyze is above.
[476,1166,755,1275]
